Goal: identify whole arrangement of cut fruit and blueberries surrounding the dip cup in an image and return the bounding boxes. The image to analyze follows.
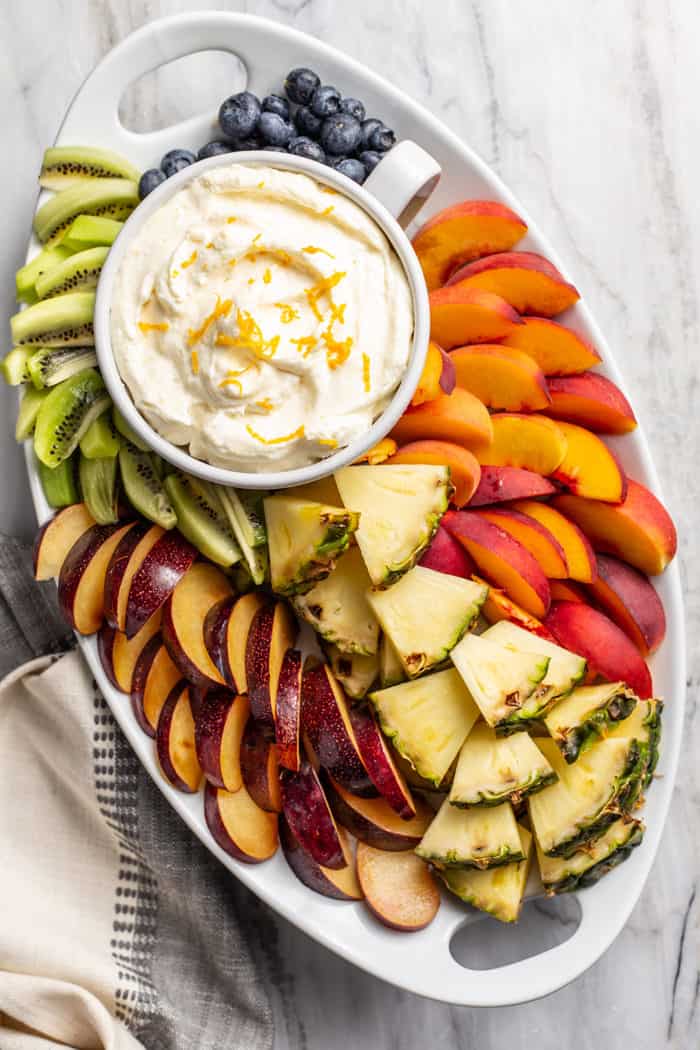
[2,10,676,1007]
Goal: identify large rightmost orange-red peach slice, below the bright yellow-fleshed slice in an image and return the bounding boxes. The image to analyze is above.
[554,480,678,576]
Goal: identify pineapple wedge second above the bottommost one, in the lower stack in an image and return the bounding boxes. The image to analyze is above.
[449,721,556,806]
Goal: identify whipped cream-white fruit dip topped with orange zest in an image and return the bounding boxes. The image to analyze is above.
[110,163,413,473]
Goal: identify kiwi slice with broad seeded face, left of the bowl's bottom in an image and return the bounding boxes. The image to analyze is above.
[34,369,110,466]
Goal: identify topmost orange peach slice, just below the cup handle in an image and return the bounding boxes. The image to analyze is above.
[413,201,528,291]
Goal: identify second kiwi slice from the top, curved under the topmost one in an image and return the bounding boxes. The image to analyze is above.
[34,179,139,248]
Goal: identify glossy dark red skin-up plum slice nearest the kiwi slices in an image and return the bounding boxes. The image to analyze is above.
[125,529,198,638]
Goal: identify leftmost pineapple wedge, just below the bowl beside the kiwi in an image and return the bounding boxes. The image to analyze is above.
[263,495,359,595]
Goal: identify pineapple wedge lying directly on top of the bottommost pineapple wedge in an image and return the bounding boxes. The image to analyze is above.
[416,799,525,869]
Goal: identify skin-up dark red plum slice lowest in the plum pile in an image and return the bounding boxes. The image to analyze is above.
[280,760,347,868]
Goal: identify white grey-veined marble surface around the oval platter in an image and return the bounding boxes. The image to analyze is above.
[0,0,700,1050]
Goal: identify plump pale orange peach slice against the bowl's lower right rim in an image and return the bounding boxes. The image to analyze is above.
[391,386,493,448]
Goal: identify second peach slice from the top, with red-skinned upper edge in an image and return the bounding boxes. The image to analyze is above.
[447,252,580,317]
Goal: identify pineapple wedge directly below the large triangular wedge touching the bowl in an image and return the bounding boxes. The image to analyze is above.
[367,565,488,678]
